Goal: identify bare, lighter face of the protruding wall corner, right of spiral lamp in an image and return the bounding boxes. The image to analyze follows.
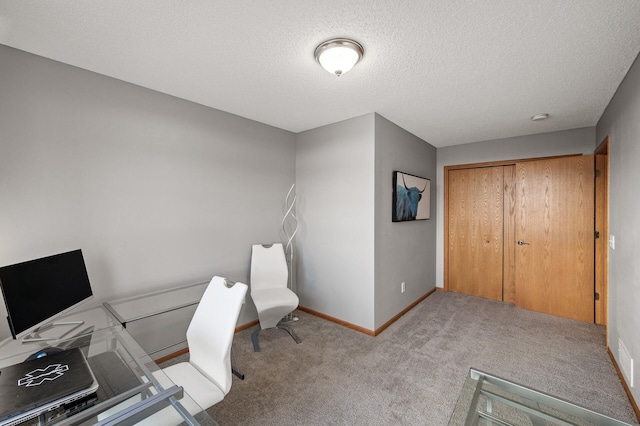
[296,114,375,330]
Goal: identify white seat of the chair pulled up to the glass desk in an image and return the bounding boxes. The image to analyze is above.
[162,362,224,414]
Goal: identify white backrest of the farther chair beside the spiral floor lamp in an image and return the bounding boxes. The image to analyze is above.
[250,243,289,291]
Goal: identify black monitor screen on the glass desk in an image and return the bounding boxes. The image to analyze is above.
[0,250,93,338]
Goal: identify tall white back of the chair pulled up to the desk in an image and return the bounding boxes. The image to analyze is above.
[187,276,247,395]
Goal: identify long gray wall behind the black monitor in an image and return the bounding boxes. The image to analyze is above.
[0,45,295,338]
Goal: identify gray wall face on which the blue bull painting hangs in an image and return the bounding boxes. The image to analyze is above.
[375,115,437,328]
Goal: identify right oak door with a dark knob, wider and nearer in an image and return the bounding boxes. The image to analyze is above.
[515,156,594,322]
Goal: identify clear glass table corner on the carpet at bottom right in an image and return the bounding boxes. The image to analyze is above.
[449,369,631,426]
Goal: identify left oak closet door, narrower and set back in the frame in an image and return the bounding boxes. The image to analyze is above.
[447,166,504,300]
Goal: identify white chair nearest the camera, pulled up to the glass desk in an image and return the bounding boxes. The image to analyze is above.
[163,276,247,414]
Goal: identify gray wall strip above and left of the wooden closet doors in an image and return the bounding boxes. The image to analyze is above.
[436,127,596,287]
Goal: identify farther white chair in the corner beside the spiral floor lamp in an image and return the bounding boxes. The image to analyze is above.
[250,243,301,352]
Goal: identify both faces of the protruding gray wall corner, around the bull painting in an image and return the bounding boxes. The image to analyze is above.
[296,114,436,331]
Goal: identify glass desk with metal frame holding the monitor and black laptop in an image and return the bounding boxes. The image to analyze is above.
[0,306,216,426]
